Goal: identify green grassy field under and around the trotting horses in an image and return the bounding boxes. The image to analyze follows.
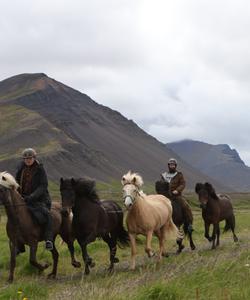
[0,183,250,300]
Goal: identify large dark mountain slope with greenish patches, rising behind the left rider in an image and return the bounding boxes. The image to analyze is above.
[0,73,228,189]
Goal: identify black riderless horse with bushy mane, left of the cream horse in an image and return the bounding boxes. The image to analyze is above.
[60,178,129,275]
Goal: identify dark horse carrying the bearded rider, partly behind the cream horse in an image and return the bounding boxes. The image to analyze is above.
[155,180,195,253]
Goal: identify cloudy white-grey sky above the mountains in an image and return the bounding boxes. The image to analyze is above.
[0,0,250,166]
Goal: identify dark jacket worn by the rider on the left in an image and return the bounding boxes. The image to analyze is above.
[16,161,51,209]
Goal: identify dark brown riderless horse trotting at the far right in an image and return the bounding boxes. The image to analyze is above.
[195,182,238,249]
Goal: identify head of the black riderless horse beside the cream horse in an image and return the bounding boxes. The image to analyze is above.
[60,178,75,215]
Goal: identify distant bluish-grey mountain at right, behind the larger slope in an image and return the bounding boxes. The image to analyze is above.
[166,140,250,192]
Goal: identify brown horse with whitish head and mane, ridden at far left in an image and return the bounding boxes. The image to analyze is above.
[0,172,80,283]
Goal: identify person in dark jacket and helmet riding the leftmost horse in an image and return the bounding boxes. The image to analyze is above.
[16,148,53,252]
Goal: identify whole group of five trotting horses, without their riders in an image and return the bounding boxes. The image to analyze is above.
[0,171,238,282]
